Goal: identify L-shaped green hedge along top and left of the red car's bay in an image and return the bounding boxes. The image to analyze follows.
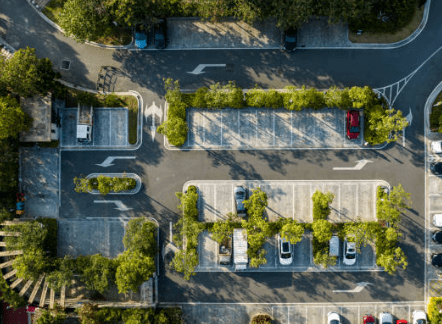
[158,79,385,146]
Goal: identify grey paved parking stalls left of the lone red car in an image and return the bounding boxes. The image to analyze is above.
[181,108,364,150]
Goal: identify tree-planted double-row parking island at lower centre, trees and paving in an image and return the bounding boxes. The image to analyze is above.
[168,181,411,279]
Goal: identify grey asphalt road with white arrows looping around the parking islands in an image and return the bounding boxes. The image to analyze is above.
[0,0,442,302]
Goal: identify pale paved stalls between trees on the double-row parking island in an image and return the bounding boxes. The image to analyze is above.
[184,180,389,272]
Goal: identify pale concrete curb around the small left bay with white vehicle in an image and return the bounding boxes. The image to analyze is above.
[57,79,144,151]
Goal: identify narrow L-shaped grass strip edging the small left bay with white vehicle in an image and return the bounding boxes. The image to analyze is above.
[64,88,138,145]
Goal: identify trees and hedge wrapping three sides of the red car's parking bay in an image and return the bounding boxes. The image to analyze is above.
[158,79,408,147]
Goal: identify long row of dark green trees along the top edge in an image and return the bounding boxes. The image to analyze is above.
[58,0,417,42]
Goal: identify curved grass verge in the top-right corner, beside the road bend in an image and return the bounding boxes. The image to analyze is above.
[348,6,424,44]
